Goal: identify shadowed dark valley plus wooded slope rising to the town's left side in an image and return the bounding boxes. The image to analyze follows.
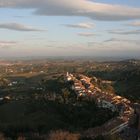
[0,75,116,138]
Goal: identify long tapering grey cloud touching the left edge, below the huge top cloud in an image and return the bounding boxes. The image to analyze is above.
[0,23,43,31]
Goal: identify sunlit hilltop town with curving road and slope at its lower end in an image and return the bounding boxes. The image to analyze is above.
[66,73,140,140]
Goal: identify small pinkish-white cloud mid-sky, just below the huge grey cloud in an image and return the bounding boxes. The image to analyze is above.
[64,23,95,29]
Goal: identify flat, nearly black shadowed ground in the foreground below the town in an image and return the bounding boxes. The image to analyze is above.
[0,99,114,137]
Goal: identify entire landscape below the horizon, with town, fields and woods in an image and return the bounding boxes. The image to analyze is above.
[0,60,140,140]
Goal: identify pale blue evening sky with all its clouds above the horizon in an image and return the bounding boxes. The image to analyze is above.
[0,0,140,58]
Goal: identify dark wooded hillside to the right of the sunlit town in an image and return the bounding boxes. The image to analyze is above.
[86,61,140,102]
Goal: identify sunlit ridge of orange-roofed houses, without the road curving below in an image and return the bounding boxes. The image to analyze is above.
[67,73,133,118]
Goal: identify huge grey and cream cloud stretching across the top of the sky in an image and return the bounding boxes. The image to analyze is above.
[0,0,140,21]
